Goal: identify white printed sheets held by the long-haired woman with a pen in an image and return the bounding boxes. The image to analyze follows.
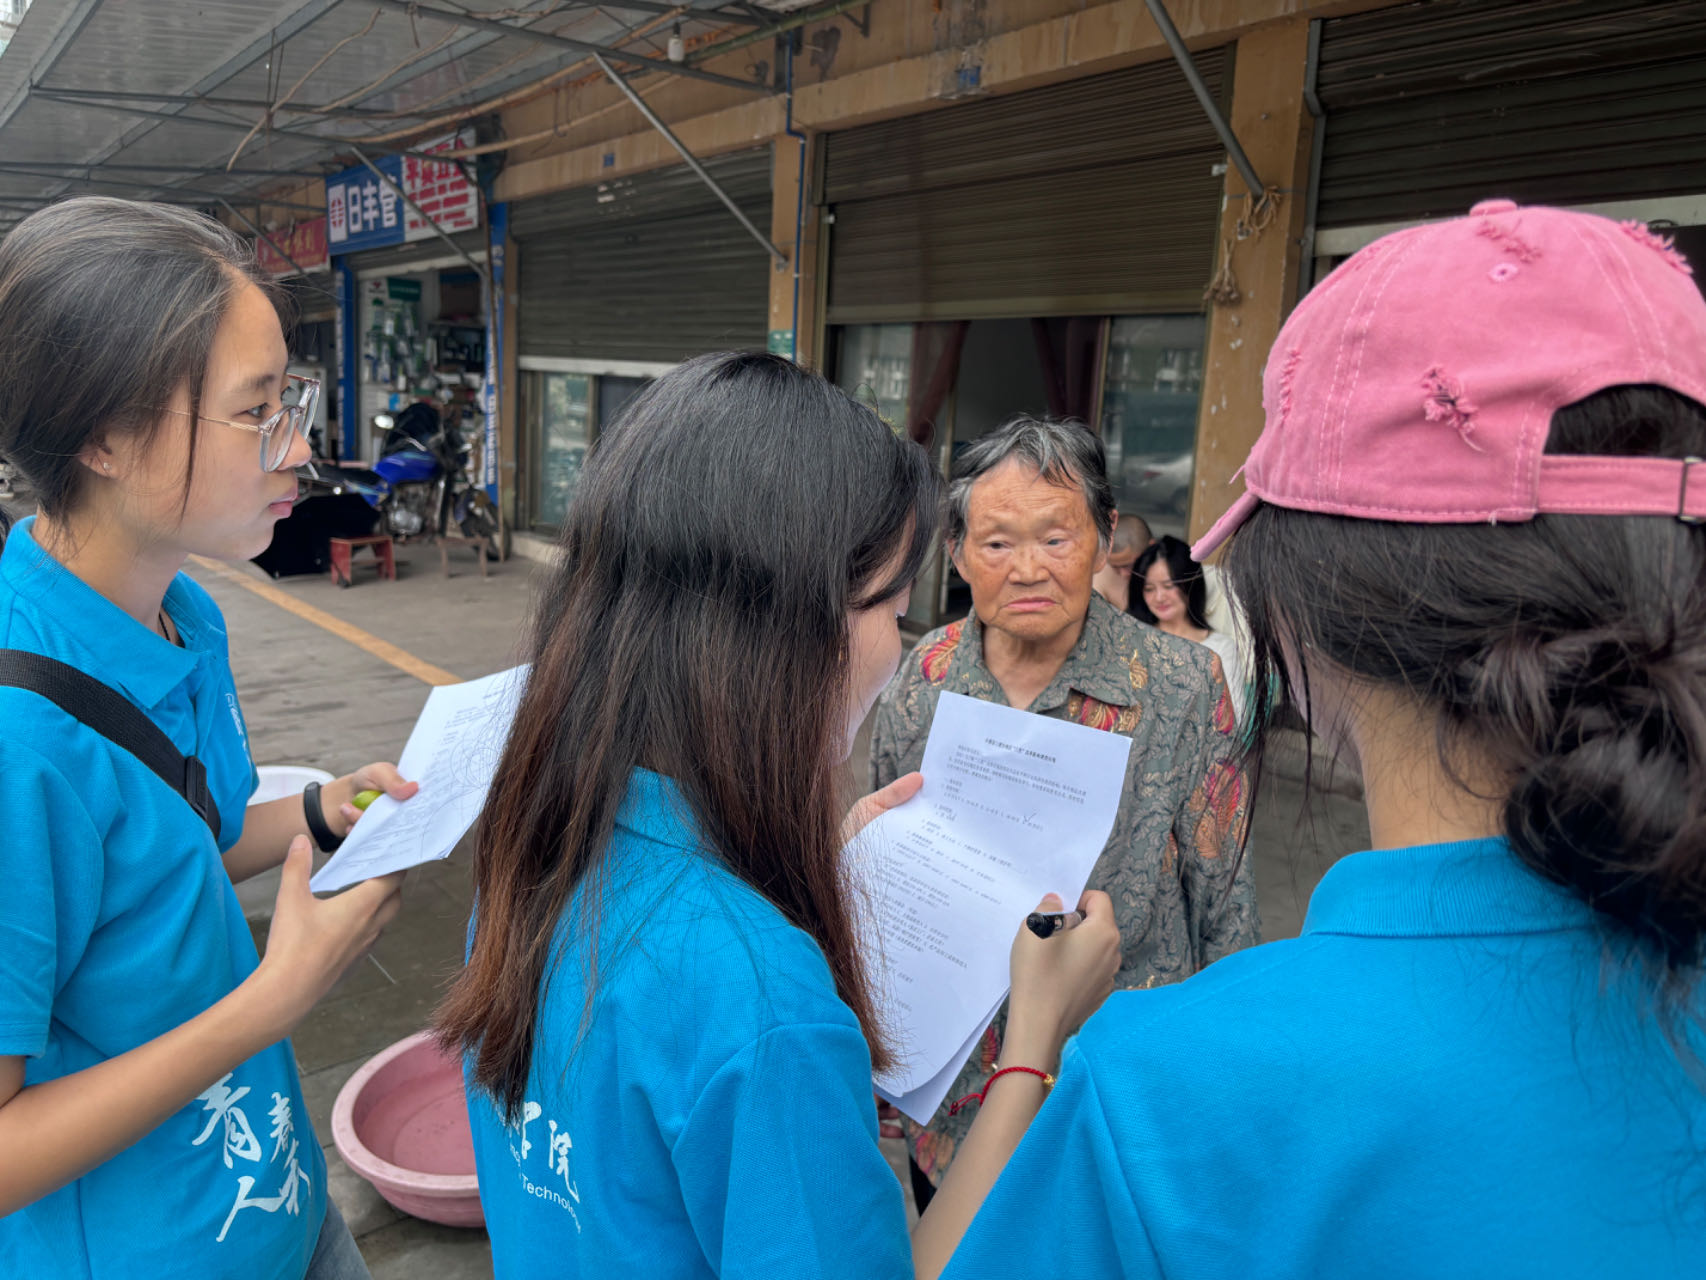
[850,693,1131,1123]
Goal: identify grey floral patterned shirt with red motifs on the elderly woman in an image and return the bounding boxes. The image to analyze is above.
[870,596,1261,1184]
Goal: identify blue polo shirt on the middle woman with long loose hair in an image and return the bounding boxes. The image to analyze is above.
[469,770,913,1280]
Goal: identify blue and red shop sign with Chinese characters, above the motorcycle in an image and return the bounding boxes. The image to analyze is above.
[326,130,479,254]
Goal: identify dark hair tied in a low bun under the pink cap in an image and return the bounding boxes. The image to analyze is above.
[1225,386,1706,1010]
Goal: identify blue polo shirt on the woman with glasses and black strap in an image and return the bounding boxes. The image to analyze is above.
[0,521,326,1280]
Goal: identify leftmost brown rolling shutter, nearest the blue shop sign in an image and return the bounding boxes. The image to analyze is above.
[510,147,771,362]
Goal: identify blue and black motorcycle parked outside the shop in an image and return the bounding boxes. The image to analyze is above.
[300,403,505,558]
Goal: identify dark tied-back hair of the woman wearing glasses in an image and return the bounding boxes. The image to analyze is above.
[0,196,288,536]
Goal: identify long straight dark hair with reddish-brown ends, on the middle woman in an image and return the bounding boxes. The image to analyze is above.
[437,353,940,1114]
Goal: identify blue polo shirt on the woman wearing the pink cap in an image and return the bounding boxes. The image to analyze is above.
[945,840,1706,1280]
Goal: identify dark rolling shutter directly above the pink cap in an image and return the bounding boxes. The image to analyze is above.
[1317,0,1706,227]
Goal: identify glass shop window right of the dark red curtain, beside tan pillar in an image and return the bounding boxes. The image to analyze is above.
[1102,316,1203,538]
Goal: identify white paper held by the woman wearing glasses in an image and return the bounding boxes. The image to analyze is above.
[309,667,527,893]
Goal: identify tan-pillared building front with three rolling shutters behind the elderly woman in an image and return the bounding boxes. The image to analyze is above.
[293,0,1706,600]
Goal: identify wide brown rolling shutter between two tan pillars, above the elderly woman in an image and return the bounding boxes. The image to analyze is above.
[821,49,1228,324]
